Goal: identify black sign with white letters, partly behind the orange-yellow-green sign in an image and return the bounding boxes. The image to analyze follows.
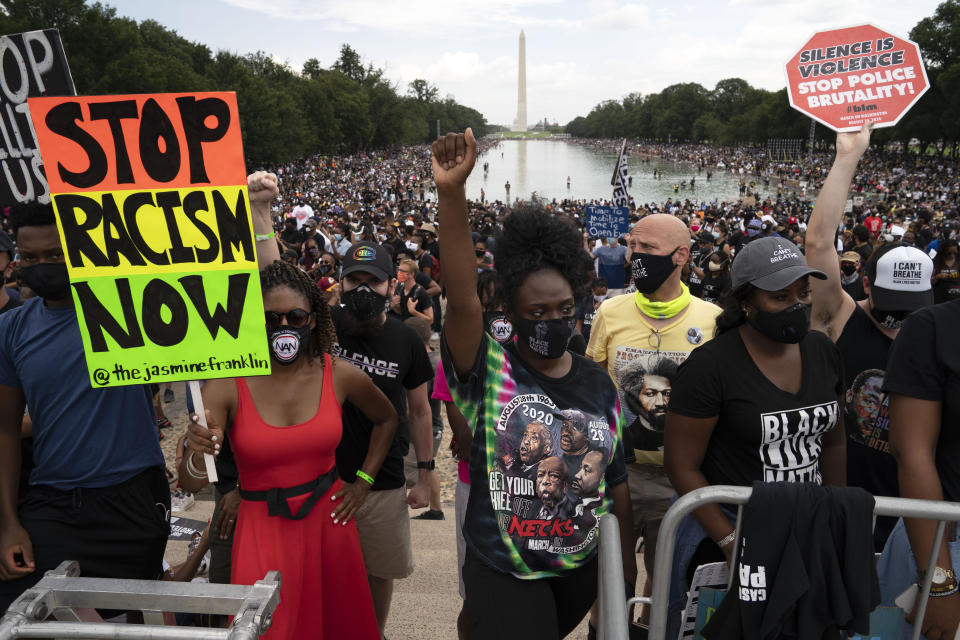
[0,29,76,207]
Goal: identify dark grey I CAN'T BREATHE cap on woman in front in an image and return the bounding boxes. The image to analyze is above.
[730,236,827,291]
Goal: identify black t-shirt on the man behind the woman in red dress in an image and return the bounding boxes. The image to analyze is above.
[330,307,433,491]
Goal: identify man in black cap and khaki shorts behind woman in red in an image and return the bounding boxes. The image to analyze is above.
[331,242,434,635]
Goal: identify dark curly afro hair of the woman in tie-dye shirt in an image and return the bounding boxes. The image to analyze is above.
[493,205,594,308]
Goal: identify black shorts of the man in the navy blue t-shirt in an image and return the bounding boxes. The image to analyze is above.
[0,467,170,612]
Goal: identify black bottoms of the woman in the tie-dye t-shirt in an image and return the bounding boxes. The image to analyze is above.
[463,546,598,640]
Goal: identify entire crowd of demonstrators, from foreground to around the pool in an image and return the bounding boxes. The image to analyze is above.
[0,129,960,638]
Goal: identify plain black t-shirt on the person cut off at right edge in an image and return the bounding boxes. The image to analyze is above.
[883,300,960,502]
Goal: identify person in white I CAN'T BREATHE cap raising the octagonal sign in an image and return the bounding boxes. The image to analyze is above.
[806,128,933,551]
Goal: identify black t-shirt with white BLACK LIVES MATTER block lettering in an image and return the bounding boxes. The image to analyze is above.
[670,330,843,486]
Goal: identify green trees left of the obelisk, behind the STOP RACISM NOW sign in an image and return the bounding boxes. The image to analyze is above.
[0,0,487,166]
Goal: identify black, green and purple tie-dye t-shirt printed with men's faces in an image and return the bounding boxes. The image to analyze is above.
[442,335,627,579]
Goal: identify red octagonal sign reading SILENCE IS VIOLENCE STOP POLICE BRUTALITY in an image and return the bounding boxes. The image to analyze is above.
[786,24,929,131]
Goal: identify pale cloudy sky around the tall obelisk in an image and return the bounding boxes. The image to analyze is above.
[106,0,939,125]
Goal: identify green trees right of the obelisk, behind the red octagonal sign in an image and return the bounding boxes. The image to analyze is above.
[566,0,960,147]
